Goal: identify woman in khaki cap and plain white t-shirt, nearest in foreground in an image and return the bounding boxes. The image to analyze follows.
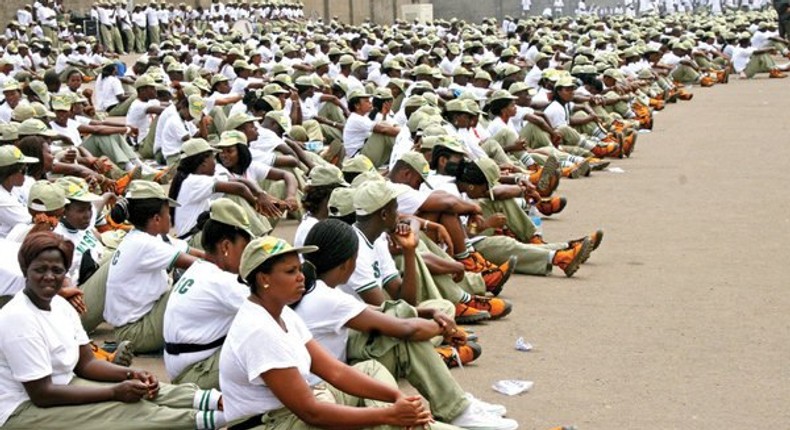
[220,236,440,430]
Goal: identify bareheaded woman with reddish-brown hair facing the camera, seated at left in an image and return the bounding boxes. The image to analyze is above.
[0,232,225,430]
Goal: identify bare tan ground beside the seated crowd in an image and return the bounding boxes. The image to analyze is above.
[97,75,790,429]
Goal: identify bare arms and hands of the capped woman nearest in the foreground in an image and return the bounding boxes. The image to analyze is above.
[261,340,432,429]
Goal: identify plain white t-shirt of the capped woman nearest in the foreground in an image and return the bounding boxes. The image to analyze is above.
[219,300,312,421]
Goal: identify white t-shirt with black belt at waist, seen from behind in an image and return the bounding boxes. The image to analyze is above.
[164,261,250,379]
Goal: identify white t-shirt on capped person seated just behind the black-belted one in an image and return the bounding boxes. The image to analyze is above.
[104,229,183,327]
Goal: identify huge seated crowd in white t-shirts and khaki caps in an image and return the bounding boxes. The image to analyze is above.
[0,1,790,430]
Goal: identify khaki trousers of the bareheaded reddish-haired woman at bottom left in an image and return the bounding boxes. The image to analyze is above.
[3,377,197,430]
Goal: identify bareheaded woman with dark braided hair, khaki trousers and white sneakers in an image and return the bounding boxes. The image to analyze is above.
[293,219,518,429]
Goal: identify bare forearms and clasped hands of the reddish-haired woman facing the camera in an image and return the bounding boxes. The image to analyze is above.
[22,345,159,408]
